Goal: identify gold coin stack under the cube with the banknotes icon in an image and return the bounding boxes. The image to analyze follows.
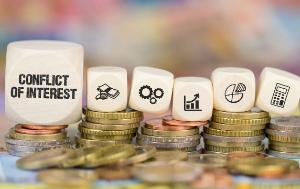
[76,109,143,147]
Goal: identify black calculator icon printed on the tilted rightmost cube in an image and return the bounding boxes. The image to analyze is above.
[271,83,290,108]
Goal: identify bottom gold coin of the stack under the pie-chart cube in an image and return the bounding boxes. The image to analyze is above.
[205,144,264,153]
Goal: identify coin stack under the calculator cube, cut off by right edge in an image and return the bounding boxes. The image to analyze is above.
[266,116,300,159]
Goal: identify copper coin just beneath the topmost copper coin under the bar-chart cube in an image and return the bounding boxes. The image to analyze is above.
[144,118,193,131]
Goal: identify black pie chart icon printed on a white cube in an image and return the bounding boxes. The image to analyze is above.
[225,83,246,103]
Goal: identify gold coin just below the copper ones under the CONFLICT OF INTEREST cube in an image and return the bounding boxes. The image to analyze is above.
[9,129,67,140]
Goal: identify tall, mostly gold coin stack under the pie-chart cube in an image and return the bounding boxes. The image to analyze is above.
[203,108,270,153]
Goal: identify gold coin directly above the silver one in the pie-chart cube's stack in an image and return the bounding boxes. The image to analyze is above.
[210,121,266,131]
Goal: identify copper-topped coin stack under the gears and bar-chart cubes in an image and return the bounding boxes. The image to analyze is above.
[137,116,208,151]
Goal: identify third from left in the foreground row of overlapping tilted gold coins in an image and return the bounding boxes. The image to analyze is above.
[84,144,135,168]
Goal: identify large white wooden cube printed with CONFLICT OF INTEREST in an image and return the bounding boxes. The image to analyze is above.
[5,40,83,125]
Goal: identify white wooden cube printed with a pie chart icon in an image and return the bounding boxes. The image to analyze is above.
[211,67,255,112]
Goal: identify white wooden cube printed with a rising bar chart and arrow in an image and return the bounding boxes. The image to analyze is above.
[172,77,213,121]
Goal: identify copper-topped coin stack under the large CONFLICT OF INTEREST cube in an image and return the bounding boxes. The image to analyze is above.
[5,124,70,156]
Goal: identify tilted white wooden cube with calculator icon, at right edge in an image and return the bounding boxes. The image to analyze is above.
[256,67,300,116]
